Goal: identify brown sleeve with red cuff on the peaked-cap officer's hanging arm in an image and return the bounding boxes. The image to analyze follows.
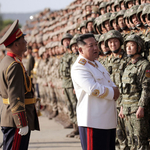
[7,63,28,128]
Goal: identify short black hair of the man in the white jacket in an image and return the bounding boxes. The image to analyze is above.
[77,33,95,46]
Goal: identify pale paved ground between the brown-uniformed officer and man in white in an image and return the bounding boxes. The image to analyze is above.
[29,116,81,150]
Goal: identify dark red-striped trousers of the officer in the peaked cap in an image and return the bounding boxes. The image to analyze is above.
[1,127,31,150]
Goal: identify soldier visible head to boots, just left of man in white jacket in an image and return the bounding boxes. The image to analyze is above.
[60,33,79,137]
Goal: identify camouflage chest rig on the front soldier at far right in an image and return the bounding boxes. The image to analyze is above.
[122,59,145,107]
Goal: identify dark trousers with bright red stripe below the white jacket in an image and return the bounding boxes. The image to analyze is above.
[79,126,116,150]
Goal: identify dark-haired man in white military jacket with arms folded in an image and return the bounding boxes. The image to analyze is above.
[71,33,119,150]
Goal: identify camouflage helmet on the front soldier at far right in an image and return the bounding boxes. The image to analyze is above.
[124,34,144,49]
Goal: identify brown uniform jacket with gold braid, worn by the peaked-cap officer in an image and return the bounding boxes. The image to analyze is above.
[0,55,39,130]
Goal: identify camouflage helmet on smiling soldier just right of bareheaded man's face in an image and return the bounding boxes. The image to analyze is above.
[104,30,123,47]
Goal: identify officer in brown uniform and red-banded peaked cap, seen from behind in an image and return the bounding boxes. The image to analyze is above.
[0,20,39,150]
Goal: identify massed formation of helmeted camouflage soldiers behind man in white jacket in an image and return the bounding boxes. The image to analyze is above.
[0,0,150,150]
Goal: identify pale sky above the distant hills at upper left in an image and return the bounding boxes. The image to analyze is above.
[0,0,73,13]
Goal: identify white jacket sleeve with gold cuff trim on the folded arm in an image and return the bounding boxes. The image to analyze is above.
[71,66,114,100]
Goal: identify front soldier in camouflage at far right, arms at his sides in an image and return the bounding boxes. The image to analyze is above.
[119,35,150,150]
